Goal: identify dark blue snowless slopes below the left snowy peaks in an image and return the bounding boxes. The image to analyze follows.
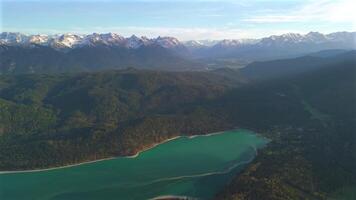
[0,45,204,74]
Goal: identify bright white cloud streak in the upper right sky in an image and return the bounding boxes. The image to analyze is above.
[244,0,356,26]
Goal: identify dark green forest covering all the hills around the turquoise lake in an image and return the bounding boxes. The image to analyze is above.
[0,51,356,200]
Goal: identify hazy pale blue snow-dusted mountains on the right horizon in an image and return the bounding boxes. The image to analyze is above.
[189,32,356,61]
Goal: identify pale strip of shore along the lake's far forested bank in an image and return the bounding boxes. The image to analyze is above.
[0,131,231,175]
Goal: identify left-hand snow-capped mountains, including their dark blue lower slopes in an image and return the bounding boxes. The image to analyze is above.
[0,32,203,74]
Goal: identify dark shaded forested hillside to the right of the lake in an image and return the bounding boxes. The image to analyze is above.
[217,52,356,200]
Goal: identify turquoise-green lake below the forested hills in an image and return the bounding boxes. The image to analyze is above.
[0,130,268,200]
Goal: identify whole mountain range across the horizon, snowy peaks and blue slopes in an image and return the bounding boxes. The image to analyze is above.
[0,32,356,74]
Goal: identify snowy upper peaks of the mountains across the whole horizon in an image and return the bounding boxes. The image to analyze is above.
[0,32,356,49]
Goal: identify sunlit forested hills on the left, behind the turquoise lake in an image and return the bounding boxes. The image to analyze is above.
[0,69,240,170]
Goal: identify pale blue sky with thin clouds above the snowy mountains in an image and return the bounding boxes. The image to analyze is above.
[0,0,356,40]
